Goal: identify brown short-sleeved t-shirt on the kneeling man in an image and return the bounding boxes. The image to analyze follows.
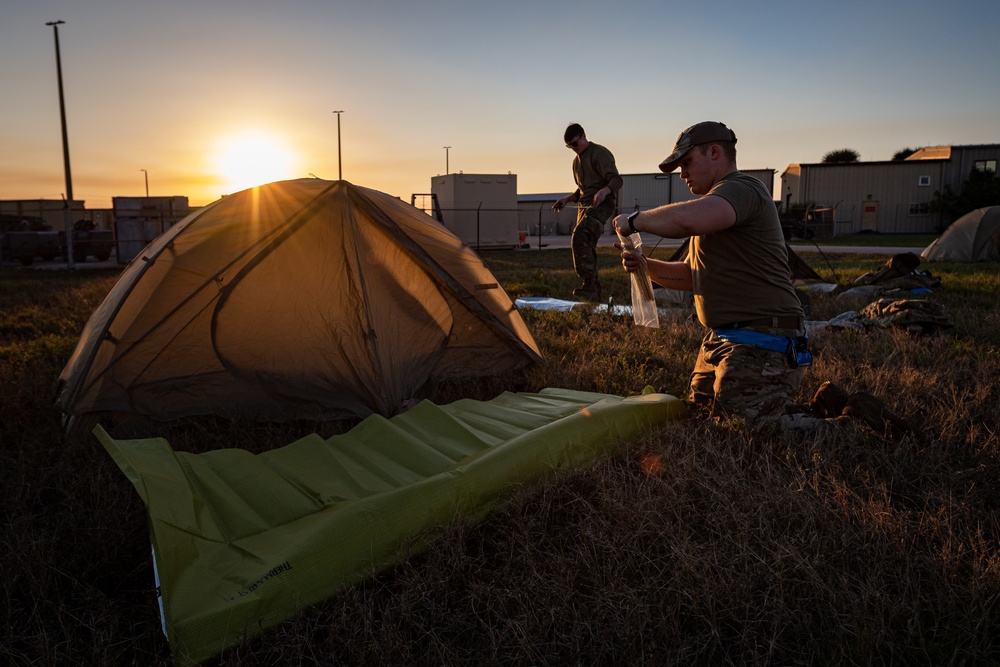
[687,171,803,329]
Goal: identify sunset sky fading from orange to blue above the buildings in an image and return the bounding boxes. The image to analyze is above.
[0,0,1000,208]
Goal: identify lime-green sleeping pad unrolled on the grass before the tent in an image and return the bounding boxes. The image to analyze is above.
[94,389,685,664]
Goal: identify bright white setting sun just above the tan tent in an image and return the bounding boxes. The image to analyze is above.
[216,132,295,194]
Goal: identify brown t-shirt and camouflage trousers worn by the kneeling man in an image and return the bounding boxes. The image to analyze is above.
[686,171,805,422]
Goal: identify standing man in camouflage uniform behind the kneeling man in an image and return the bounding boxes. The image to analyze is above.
[552,123,622,301]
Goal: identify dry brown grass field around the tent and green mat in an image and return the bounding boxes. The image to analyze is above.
[0,244,1000,665]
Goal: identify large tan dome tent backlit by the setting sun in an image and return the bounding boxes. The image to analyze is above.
[57,179,542,428]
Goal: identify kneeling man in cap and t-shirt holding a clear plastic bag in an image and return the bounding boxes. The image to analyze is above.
[614,121,808,428]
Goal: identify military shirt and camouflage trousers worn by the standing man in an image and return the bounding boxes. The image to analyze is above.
[573,142,623,295]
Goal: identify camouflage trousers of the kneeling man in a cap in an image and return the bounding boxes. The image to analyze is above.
[688,329,803,422]
